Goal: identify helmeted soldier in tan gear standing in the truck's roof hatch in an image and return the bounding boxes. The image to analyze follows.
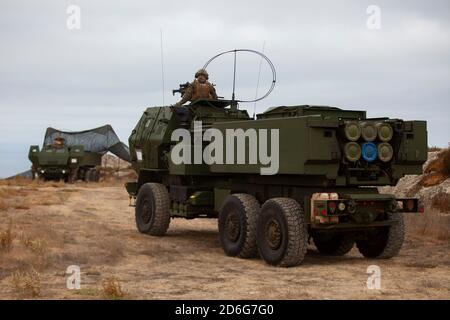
[175,69,217,107]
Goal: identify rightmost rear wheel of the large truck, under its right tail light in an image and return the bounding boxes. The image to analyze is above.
[356,212,405,259]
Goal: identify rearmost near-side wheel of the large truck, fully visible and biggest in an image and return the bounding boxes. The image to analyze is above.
[256,198,308,267]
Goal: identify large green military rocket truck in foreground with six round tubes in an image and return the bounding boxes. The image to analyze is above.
[126,100,427,267]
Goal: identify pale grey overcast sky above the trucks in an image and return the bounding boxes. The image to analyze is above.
[0,0,450,177]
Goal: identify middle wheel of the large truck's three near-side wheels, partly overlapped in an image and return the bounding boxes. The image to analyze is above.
[219,194,259,258]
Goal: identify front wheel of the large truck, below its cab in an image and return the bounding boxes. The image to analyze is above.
[135,183,170,236]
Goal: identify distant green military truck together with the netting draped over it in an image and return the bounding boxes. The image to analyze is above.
[28,125,130,183]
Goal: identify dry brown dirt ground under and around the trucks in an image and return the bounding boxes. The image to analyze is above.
[0,183,450,299]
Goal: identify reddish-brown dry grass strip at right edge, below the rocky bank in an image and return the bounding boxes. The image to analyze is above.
[405,210,450,241]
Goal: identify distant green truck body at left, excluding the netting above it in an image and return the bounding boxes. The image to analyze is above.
[28,145,102,183]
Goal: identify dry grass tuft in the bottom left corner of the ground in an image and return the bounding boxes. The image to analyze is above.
[11,268,41,298]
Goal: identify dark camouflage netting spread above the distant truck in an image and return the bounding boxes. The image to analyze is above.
[44,125,131,162]
